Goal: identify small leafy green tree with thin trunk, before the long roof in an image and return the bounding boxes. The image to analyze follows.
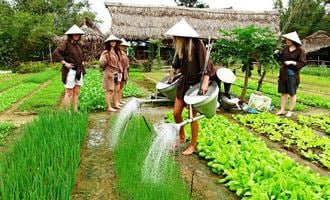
[211,25,277,99]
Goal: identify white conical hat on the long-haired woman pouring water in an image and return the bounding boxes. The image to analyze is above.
[165,19,199,38]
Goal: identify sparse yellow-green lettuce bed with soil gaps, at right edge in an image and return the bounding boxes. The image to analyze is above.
[234,113,330,168]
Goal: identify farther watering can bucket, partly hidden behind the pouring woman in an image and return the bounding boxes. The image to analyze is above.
[156,74,181,101]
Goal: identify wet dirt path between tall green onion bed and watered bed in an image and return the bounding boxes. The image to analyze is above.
[72,112,119,200]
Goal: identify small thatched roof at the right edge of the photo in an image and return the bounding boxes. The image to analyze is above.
[302,30,330,53]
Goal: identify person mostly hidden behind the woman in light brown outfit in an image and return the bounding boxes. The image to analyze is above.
[118,38,129,105]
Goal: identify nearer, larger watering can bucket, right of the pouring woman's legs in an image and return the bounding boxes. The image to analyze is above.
[184,81,219,118]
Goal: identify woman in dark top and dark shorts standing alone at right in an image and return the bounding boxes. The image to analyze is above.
[274,31,306,117]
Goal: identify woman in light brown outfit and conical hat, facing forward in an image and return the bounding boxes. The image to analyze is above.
[99,35,121,112]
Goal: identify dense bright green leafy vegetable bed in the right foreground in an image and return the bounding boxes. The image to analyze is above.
[168,115,330,199]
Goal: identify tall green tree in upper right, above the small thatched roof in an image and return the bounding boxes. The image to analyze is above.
[274,0,330,38]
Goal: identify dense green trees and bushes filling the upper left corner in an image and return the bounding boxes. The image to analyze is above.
[0,0,95,68]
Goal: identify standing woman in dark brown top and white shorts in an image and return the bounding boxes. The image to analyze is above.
[54,25,86,111]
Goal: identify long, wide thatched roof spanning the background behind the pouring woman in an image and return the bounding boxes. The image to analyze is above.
[105,2,279,40]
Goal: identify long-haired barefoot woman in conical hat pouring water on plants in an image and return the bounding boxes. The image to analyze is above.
[165,19,215,155]
